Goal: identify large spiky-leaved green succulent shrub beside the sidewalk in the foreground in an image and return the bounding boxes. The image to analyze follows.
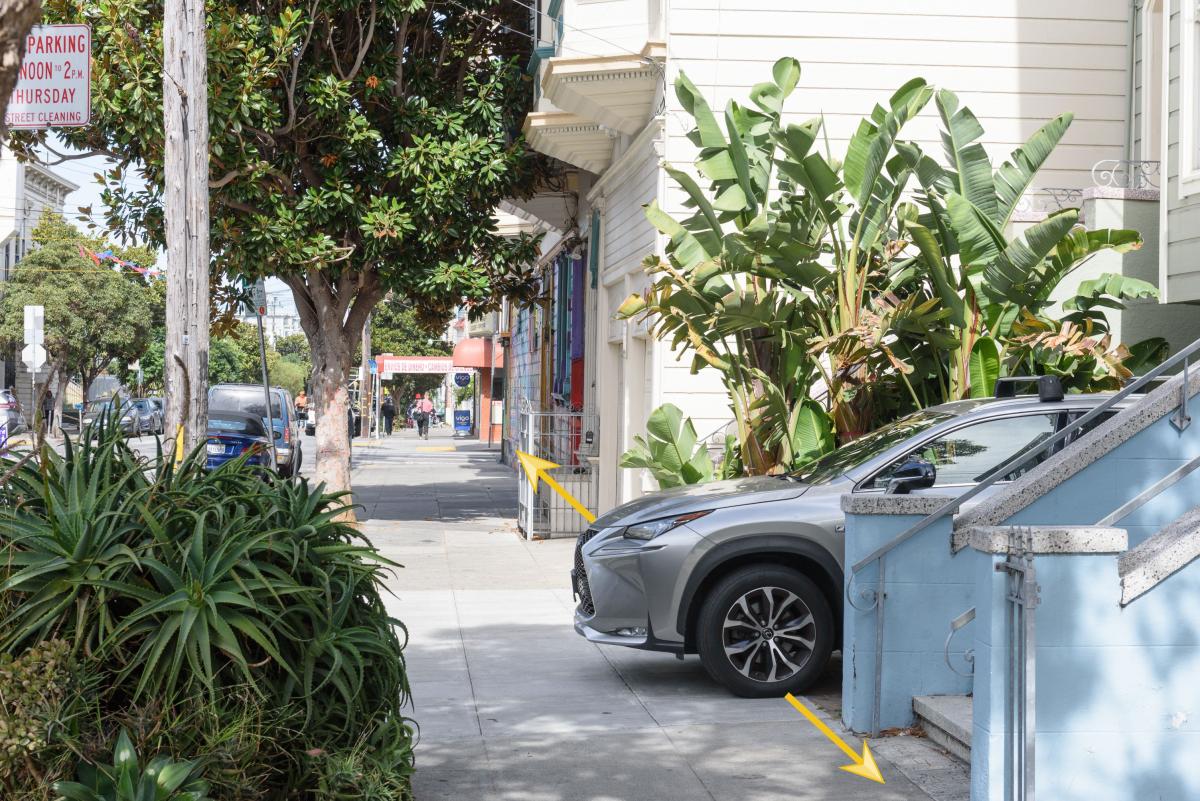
[0,424,413,801]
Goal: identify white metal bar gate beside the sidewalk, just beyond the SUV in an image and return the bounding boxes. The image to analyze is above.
[516,411,600,540]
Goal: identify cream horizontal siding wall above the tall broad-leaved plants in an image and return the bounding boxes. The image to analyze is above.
[667,0,1129,201]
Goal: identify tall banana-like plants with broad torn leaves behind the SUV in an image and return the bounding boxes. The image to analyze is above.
[618,59,1153,472]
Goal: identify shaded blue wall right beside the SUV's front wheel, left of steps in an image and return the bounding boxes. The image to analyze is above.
[841,514,984,731]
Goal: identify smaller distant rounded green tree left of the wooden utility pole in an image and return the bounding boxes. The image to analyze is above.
[0,213,152,424]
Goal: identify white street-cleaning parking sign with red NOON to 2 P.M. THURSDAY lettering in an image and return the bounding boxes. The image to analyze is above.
[4,25,91,128]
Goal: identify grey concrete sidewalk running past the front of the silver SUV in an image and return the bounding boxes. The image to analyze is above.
[354,433,968,801]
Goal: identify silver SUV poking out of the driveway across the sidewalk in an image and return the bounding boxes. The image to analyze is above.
[571,391,1108,697]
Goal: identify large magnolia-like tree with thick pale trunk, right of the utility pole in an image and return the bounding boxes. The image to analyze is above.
[12,0,536,489]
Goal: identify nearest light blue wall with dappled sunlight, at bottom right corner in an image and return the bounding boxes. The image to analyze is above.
[971,554,1200,801]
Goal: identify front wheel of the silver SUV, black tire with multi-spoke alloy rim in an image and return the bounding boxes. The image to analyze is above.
[696,565,835,698]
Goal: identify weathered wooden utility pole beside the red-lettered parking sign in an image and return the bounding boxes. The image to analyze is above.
[162,0,209,450]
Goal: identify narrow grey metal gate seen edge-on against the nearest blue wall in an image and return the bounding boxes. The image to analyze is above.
[996,528,1039,801]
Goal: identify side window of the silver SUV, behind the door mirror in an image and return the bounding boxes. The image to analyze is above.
[868,414,1060,488]
